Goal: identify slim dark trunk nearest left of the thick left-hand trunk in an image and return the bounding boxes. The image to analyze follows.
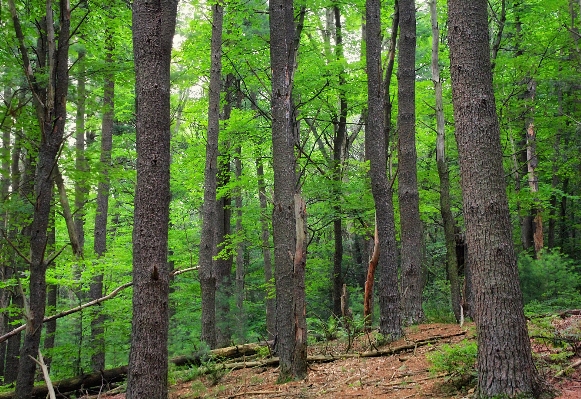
[89,31,115,371]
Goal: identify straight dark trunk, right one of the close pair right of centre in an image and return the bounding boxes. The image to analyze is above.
[397,0,424,324]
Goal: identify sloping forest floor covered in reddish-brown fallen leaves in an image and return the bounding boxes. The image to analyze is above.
[101,316,581,399]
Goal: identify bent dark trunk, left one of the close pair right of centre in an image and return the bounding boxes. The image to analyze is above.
[365,0,402,339]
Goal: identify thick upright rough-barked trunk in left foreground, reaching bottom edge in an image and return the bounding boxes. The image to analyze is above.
[127,0,178,399]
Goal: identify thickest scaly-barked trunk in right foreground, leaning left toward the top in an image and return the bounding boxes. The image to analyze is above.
[448,0,541,398]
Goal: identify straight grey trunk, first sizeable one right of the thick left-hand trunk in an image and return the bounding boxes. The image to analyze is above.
[199,3,224,349]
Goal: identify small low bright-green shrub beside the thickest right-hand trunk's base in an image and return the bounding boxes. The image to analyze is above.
[428,340,478,389]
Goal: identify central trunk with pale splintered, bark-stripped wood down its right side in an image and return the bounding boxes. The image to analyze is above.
[269,0,307,381]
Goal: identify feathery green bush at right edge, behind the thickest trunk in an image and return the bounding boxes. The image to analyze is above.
[519,250,581,314]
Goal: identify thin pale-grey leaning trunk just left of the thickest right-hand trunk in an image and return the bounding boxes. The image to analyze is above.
[430,0,461,321]
